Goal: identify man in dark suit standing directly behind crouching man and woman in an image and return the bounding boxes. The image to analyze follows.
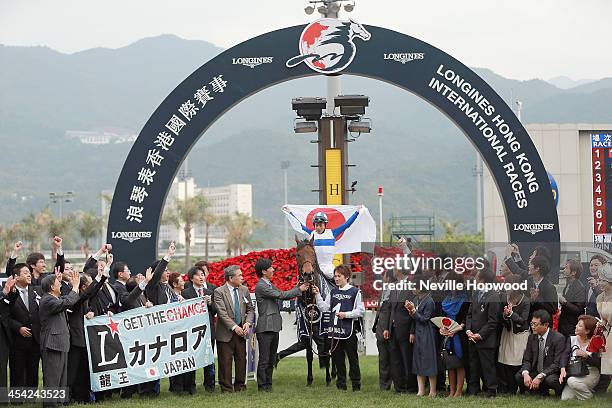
[558,259,586,337]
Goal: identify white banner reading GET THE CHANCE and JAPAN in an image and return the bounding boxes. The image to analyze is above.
[85,298,214,392]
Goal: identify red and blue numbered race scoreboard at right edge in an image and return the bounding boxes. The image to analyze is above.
[591,133,612,247]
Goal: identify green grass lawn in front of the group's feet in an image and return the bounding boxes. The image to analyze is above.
[83,357,612,408]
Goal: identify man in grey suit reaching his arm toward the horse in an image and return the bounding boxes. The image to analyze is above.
[255,258,308,391]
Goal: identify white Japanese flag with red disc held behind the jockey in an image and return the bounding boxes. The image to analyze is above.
[283,204,376,254]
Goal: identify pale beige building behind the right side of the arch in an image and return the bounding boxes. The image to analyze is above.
[483,124,612,243]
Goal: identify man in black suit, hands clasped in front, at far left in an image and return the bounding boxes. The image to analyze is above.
[8,263,42,387]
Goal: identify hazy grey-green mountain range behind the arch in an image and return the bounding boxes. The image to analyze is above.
[0,35,612,246]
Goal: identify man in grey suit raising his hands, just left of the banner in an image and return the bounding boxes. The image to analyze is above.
[39,271,81,403]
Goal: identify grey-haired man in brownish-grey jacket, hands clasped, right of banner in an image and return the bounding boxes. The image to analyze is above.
[213,265,255,392]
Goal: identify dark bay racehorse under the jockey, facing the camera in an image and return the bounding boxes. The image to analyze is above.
[278,236,336,385]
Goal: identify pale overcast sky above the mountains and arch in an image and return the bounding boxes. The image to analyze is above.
[0,0,612,79]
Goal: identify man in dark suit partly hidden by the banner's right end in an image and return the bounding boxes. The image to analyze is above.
[183,261,217,393]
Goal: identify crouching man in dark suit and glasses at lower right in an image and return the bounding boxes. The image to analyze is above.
[516,309,566,396]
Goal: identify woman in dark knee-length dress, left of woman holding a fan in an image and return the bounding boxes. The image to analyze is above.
[405,277,438,397]
